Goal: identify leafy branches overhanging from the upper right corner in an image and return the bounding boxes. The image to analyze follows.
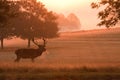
[91,0,120,28]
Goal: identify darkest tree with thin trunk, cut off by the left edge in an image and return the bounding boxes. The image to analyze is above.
[0,0,17,49]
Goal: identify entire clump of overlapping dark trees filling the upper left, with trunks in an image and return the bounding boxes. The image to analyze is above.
[0,0,58,49]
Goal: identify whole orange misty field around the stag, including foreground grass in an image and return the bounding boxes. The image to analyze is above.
[0,29,120,80]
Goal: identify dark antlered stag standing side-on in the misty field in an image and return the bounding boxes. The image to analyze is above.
[15,38,46,62]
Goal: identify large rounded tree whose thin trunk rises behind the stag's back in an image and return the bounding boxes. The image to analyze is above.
[14,0,58,47]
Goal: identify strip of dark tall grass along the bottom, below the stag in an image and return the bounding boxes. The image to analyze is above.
[0,62,120,80]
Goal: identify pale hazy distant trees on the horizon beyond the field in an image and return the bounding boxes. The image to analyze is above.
[57,13,81,32]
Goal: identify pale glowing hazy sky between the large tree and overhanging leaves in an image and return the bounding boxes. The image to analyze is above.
[40,0,104,30]
